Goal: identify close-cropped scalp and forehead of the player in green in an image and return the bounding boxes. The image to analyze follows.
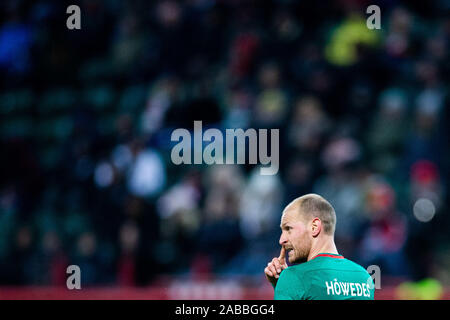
[283,193,336,235]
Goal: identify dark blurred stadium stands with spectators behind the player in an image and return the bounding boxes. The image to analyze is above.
[0,0,450,299]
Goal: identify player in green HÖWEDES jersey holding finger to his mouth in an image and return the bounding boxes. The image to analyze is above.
[264,194,374,300]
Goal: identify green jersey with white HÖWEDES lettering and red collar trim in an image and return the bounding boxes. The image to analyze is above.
[274,253,374,300]
